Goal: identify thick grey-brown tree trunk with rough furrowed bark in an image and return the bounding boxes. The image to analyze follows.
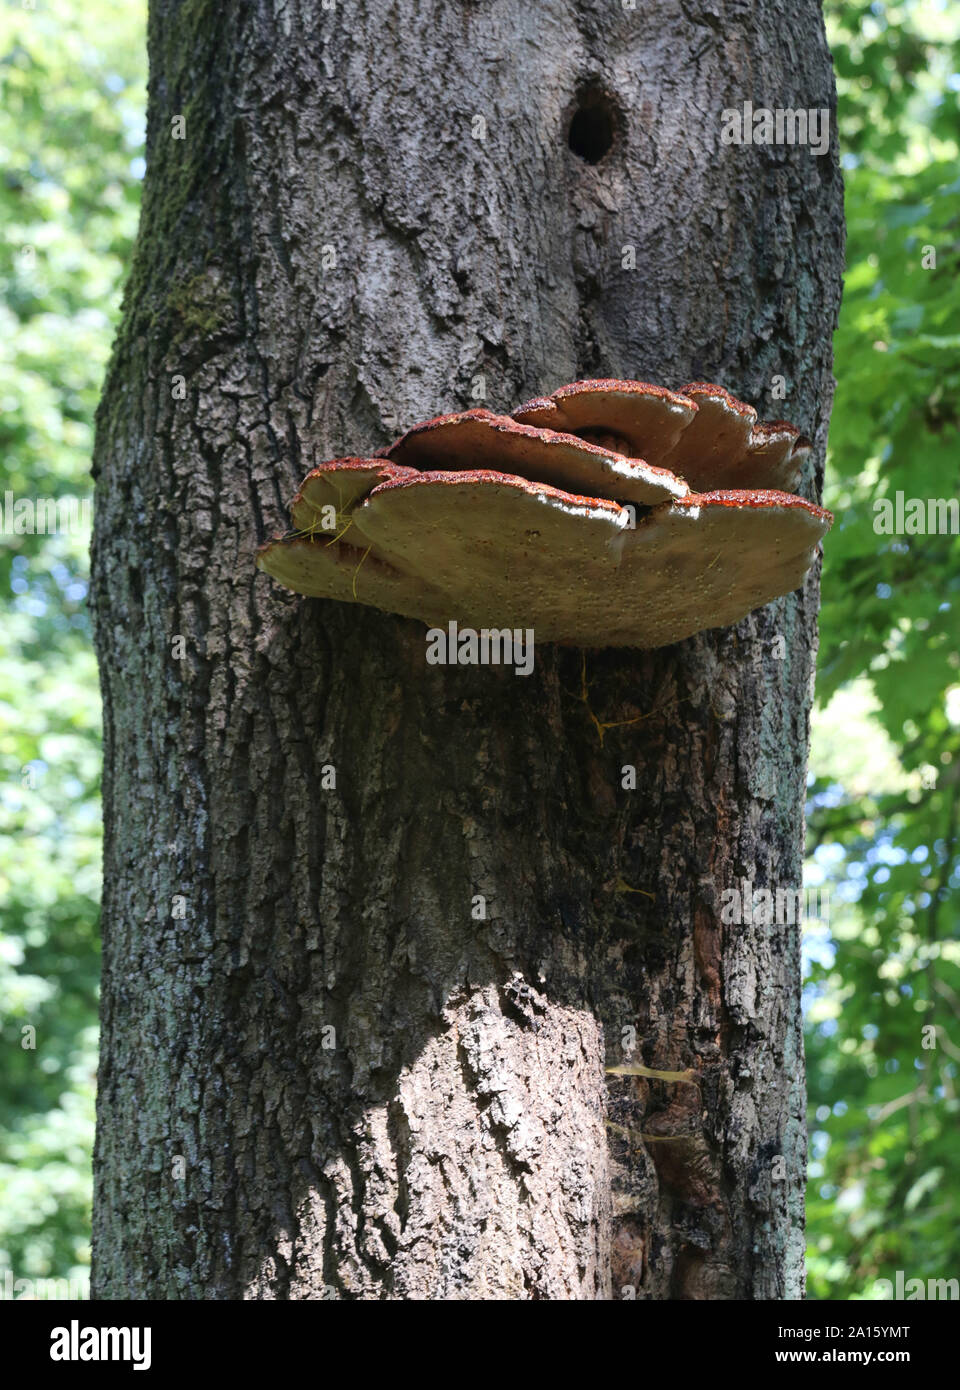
[93,0,842,1300]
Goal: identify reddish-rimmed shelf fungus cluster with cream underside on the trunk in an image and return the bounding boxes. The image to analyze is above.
[257,381,832,648]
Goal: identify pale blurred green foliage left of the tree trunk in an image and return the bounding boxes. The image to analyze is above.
[0,0,146,1277]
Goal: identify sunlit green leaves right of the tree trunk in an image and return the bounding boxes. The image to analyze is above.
[807,3,960,1298]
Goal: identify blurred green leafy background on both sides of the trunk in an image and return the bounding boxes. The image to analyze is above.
[0,0,960,1298]
